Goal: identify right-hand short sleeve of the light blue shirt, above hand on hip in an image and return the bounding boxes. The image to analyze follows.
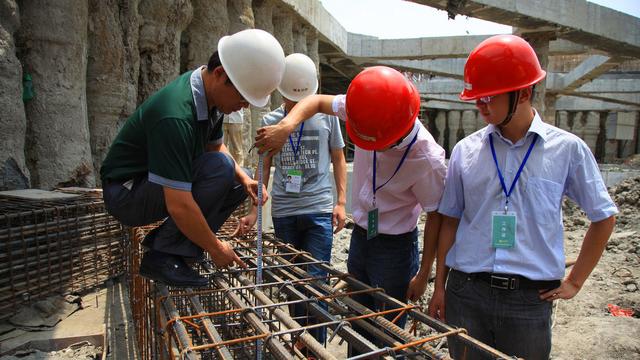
[566,142,618,222]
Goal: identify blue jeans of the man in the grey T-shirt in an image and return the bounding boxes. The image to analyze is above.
[272,213,333,343]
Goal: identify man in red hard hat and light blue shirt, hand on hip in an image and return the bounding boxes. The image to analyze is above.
[429,35,618,359]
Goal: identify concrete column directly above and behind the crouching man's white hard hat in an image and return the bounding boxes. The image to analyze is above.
[227,0,255,166]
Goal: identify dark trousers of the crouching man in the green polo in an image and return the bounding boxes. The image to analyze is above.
[103,152,247,258]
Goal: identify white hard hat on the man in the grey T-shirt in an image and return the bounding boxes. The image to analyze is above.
[278,53,318,102]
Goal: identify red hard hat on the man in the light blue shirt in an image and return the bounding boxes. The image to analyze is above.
[460,35,547,100]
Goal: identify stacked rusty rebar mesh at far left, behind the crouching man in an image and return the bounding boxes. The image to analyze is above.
[0,192,126,319]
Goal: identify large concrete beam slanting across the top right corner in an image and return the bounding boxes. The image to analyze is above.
[412,0,640,58]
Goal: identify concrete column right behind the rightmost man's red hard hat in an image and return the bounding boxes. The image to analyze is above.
[513,28,556,124]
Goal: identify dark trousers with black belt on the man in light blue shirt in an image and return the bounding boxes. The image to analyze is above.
[445,270,551,360]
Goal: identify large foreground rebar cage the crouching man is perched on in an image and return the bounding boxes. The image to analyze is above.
[129,222,510,359]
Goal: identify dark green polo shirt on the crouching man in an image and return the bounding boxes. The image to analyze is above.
[100,69,222,191]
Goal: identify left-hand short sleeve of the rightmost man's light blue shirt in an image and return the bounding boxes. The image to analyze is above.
[438,147,464,219]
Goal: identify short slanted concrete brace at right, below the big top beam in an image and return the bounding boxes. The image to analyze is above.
[550,55,619,92]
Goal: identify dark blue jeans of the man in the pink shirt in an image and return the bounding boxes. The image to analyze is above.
[347,225,419,355]
